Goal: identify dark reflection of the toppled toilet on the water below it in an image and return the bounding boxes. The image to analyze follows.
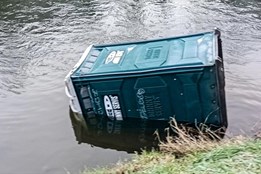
[70,111,169,152]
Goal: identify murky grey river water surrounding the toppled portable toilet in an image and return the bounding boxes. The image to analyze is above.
[0,0,261,174]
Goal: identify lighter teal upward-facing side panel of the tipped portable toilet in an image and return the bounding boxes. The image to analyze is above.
[74,32,217,76]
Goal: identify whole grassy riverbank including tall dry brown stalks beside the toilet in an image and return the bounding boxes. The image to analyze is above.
[83,121,261,174]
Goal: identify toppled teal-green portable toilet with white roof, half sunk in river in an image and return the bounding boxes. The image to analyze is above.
[65,30,227,127]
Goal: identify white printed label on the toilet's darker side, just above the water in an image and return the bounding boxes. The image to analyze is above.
[103,95,122,120]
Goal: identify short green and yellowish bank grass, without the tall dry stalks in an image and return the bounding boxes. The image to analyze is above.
[82,137,261,174]
